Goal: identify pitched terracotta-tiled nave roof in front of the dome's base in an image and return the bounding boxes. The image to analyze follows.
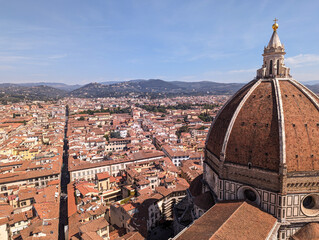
[175,202,277,240]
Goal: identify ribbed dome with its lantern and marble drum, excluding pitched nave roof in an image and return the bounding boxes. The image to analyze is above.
[203,21,319,239]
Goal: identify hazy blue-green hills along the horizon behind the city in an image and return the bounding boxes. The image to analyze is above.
[0,79,319,102]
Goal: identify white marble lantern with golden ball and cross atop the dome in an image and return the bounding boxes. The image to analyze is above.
[257,18,290,78]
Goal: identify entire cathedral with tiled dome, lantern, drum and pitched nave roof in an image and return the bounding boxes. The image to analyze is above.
[174,21,319,240]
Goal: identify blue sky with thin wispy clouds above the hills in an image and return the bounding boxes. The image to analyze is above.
[0,0,319,84]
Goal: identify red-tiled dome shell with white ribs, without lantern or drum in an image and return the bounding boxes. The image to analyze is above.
[206,78,319,173]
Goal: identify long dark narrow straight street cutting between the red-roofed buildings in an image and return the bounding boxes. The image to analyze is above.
[59,106,70,240]
